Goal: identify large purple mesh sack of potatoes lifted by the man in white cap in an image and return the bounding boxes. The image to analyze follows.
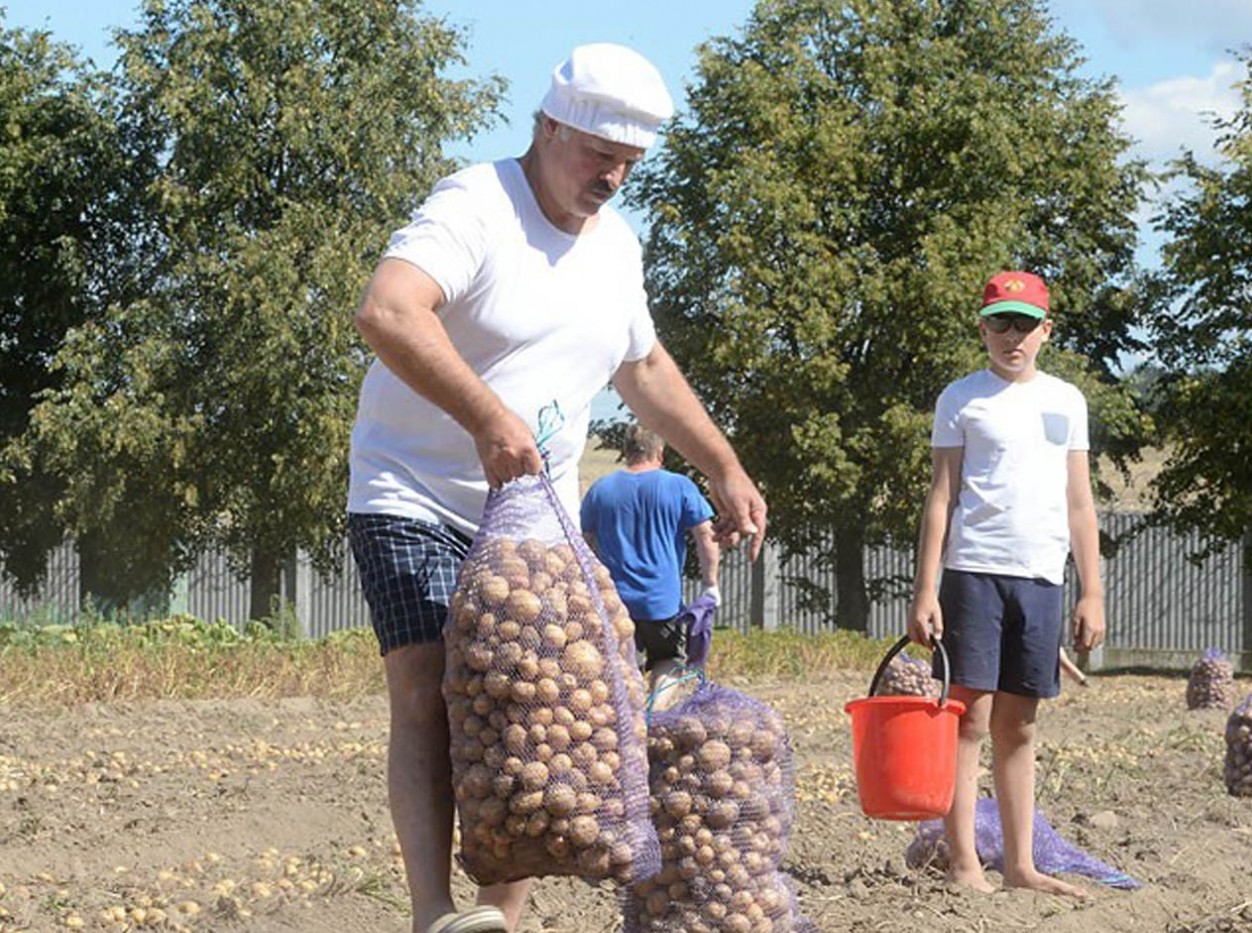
[443,477,660,884]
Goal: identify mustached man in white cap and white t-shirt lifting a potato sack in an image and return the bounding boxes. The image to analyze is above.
[348,44,766,933]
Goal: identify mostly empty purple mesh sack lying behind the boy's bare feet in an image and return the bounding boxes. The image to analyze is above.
[904,796,1139,890]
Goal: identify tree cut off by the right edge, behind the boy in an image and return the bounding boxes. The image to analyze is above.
[1151,53,1252,550]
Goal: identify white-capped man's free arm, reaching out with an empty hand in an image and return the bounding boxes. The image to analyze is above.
[613,341,766,560]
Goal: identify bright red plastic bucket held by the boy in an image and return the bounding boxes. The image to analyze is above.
[844,636,965,820]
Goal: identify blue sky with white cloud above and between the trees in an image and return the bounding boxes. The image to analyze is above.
[9,0,1252,417]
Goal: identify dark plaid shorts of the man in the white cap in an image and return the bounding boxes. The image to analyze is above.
[348,512,470,655]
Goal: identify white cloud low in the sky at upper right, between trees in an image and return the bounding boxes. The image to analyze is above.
[1121,61,1246,162]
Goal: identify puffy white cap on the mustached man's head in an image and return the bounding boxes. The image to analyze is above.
[540,43,674,149]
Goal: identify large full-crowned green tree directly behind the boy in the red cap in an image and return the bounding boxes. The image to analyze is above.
[632,0,1144,630]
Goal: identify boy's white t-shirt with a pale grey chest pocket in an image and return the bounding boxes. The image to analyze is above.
[930,369,1090,584]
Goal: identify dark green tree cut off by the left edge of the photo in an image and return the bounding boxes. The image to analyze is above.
[0,23,150,589]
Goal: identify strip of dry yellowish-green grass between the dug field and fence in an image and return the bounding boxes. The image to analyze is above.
[0,616,890,708]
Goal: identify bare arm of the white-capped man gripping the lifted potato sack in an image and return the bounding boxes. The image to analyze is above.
[356,259,542,486]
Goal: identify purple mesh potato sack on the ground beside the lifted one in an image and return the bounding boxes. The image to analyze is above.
[623,683,815,933]
